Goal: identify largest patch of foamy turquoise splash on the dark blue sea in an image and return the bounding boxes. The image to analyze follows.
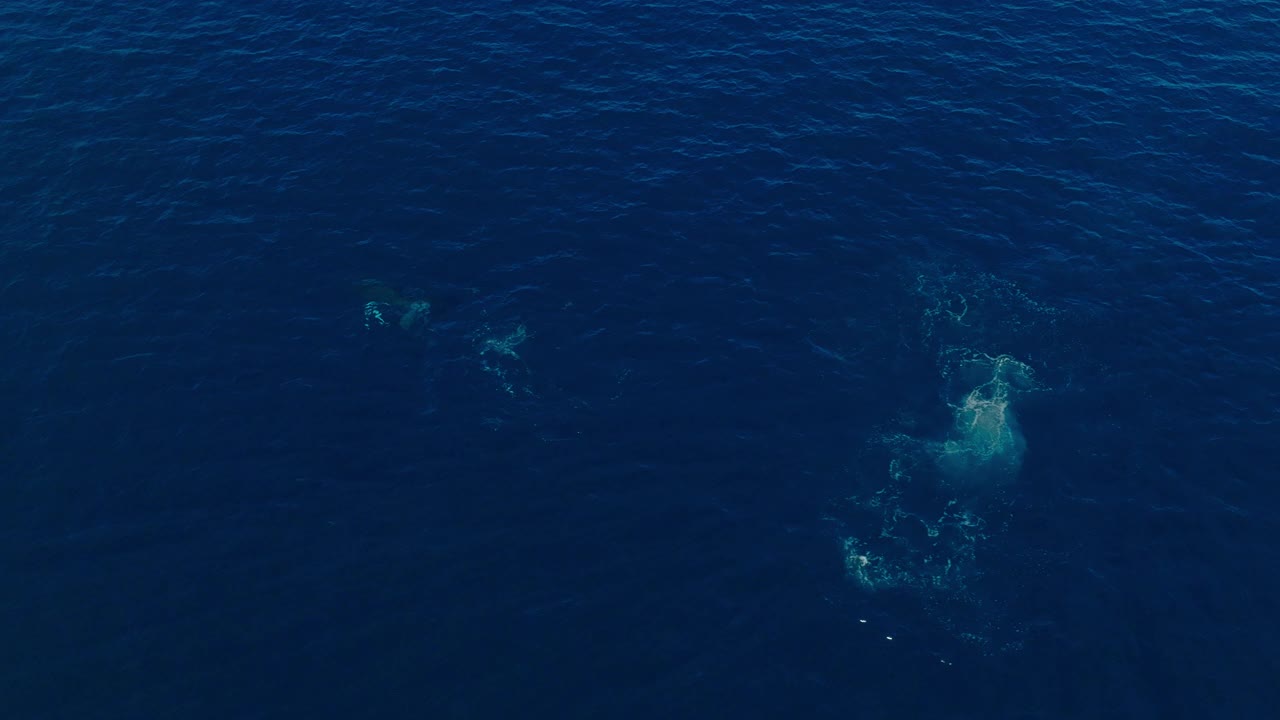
[842,269,1059,642]
